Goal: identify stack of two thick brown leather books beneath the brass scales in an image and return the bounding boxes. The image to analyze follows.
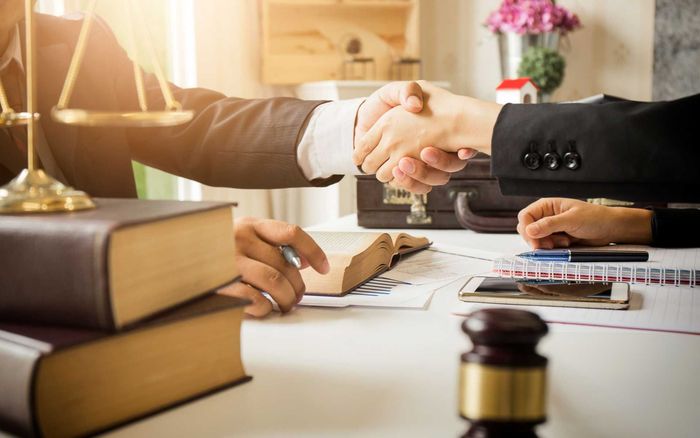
[0,199,249,437]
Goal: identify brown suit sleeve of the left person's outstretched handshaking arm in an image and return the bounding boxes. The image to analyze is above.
[97,19,342,188]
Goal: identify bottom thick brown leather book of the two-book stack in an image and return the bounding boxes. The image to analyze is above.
[0,295,250,437]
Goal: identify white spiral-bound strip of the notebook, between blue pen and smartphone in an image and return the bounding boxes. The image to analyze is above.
[493,252,700,287]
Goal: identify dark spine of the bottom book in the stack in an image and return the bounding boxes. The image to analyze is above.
[0,338,41,436]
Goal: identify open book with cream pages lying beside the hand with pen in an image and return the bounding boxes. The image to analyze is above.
[301,232,430,296]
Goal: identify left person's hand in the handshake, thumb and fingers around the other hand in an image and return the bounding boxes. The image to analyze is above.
[354,82,476,193]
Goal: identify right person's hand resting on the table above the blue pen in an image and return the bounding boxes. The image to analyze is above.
[518,198,652,249]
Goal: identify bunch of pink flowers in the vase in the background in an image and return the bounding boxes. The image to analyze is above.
[485,0,581,35]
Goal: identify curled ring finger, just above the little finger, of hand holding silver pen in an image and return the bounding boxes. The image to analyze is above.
[236,257,298,312]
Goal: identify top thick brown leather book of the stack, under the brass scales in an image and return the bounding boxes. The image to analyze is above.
[0,199,238,330]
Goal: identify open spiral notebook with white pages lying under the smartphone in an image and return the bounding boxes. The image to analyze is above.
[453,245,700,335]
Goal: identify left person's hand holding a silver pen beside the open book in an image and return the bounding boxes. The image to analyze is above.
[219,218,330,317]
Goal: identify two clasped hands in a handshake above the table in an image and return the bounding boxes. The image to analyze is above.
[353,81,501,193]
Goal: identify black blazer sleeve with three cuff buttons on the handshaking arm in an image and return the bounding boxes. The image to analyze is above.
[492,95,700,201]
